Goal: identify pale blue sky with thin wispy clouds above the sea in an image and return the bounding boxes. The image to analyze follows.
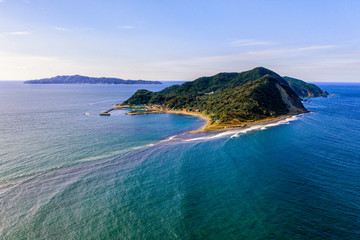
[0,0,360,82]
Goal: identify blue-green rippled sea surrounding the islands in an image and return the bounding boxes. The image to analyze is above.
[0,82,360,240]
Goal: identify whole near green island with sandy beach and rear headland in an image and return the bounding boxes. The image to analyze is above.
[116,67,327,131]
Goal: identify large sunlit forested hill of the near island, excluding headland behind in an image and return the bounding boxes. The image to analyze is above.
[123,67,307,125]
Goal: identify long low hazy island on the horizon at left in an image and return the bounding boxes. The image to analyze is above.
[24,75,162,84]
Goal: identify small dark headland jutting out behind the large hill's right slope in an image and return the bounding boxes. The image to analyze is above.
[283,77,329,98]
